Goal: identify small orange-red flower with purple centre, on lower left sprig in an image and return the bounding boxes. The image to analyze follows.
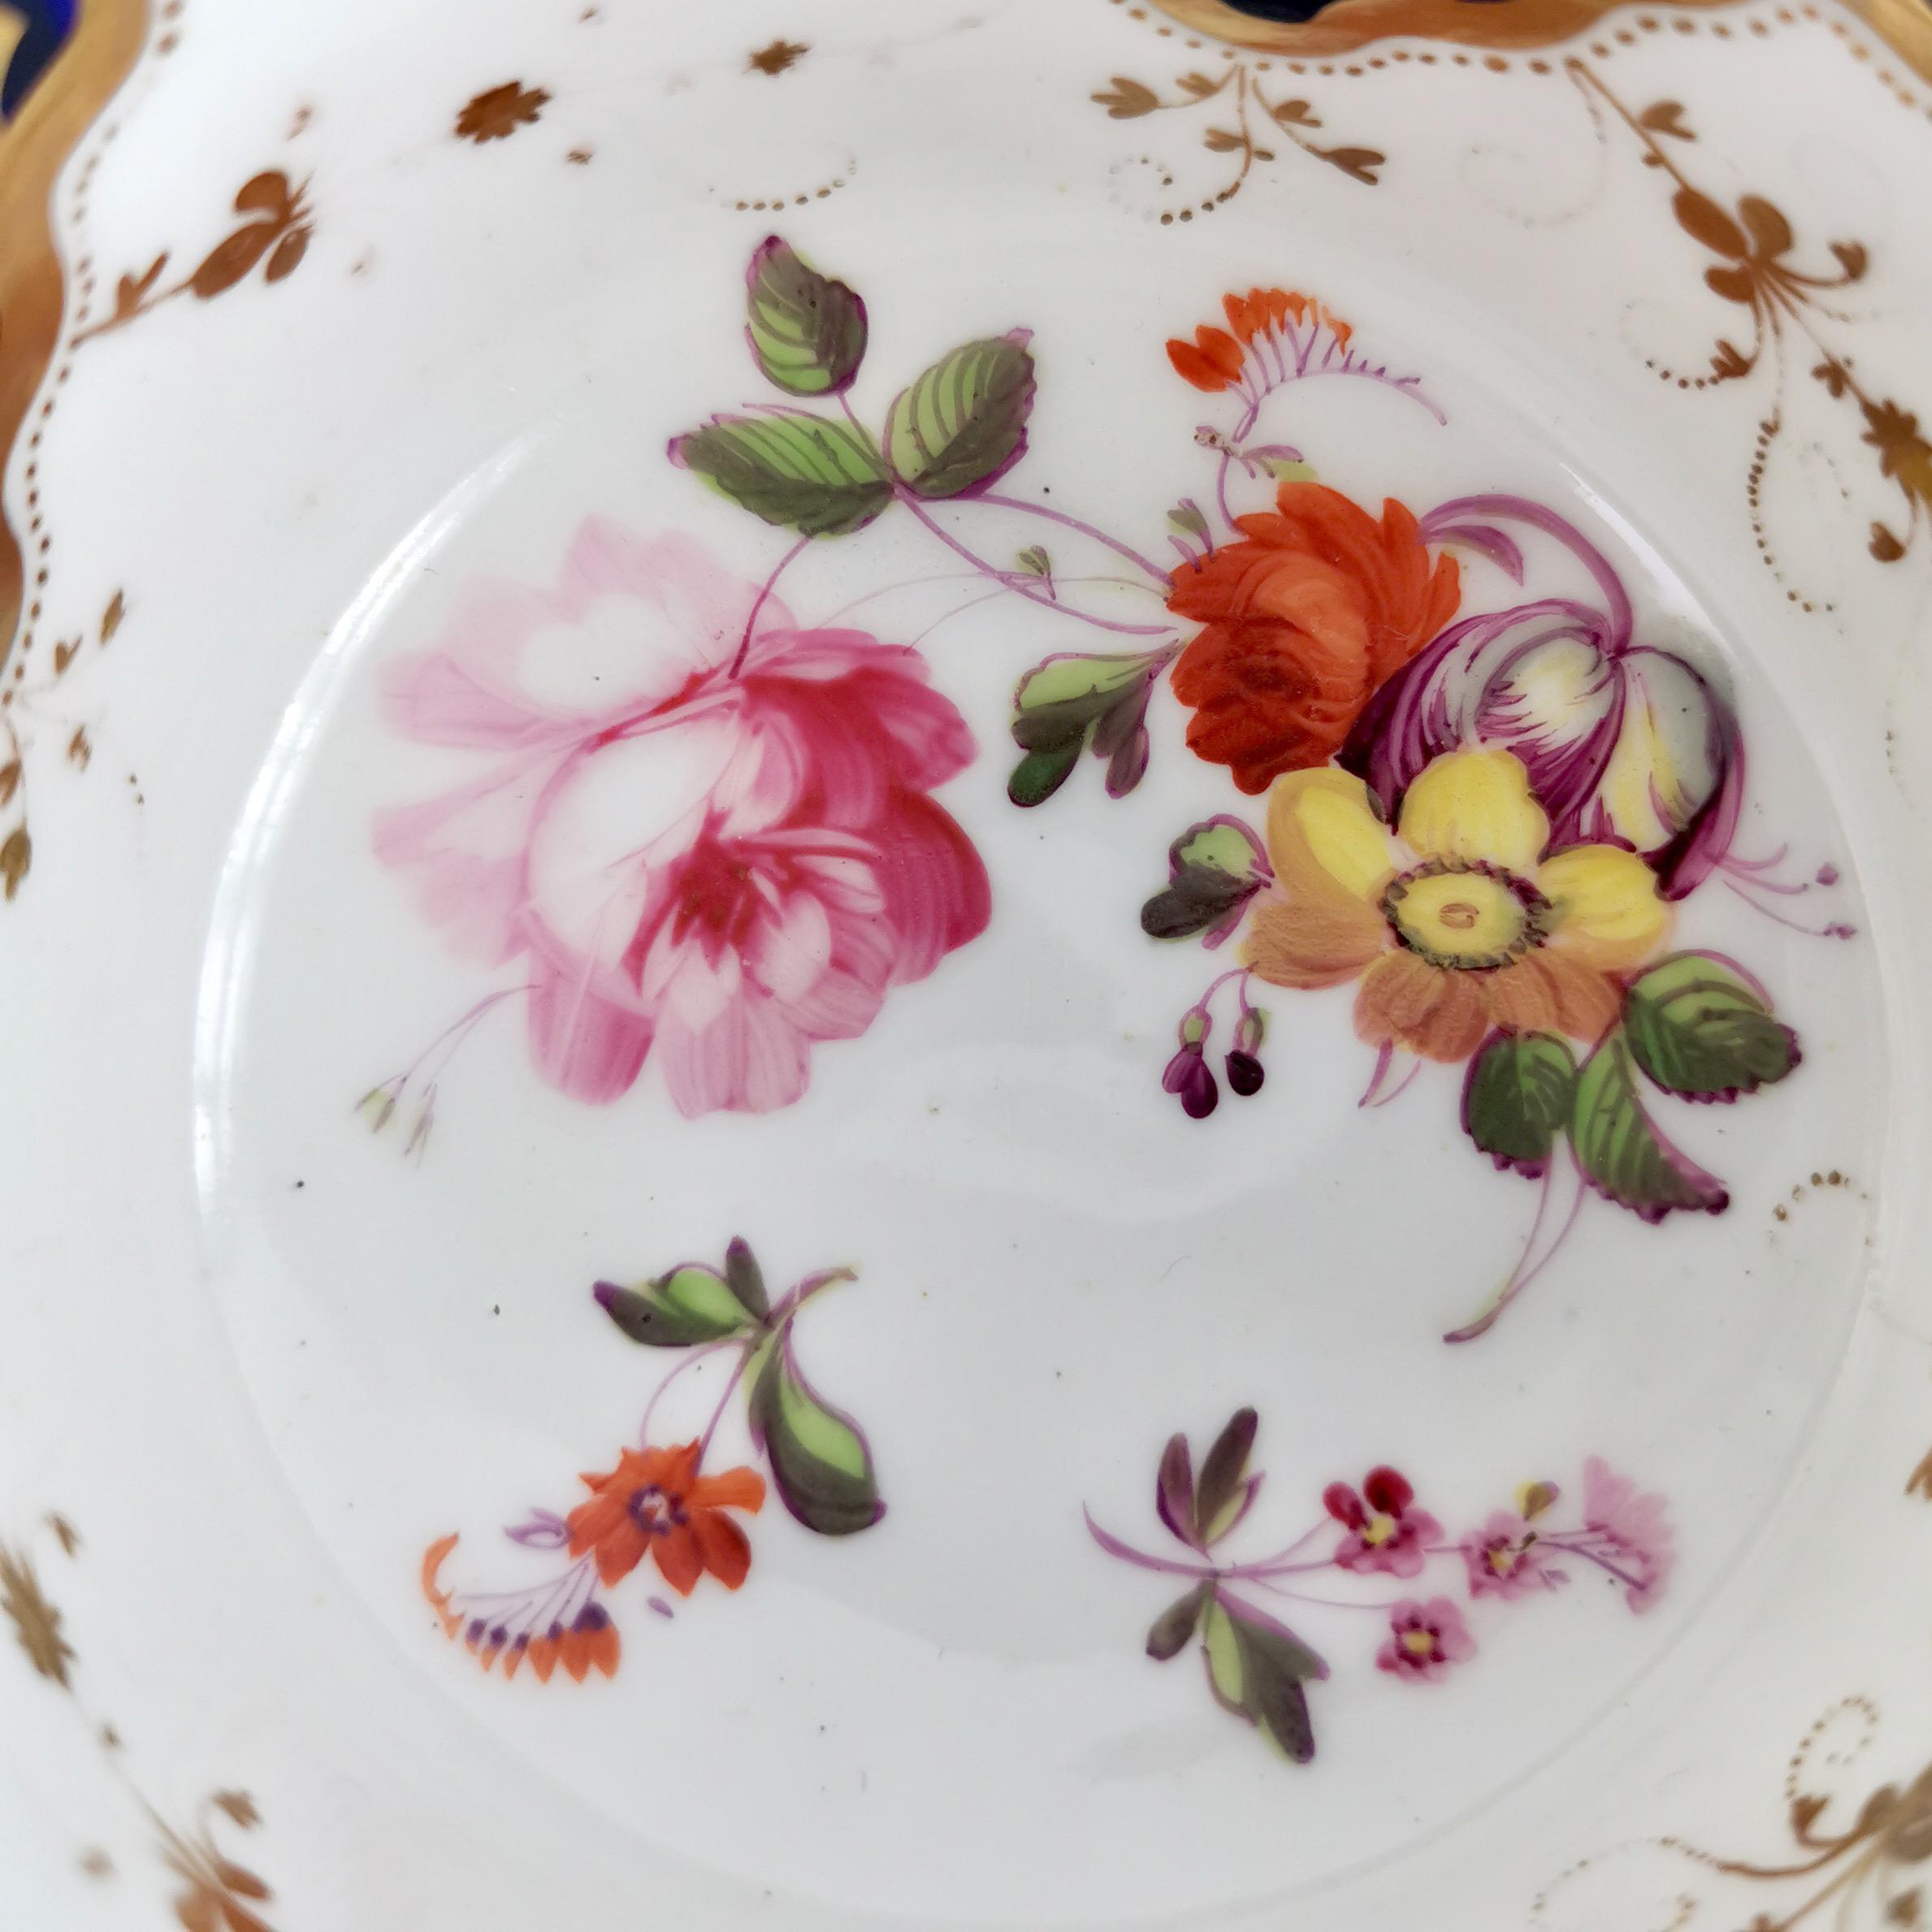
[568,1441,765,1596]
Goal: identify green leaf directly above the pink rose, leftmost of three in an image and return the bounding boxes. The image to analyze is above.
[670,412,893,537]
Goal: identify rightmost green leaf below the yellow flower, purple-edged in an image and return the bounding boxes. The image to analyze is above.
[1623,952,1800,1101]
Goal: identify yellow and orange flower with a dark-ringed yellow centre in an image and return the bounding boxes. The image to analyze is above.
[1242,752,1671,1061]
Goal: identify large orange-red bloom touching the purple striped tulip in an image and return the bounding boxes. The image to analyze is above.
[1167,483,1462,792]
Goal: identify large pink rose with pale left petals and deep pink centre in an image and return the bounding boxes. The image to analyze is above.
[375,518,990,1115]
